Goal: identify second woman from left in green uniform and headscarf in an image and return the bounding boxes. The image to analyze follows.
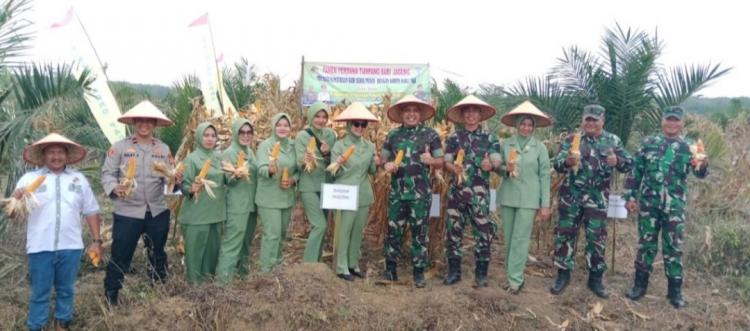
[216,119,258,284]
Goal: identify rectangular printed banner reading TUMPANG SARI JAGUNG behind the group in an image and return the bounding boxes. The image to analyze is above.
[302,62,432,106]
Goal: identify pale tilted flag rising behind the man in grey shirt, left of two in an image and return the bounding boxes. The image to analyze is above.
[50,7,125,144]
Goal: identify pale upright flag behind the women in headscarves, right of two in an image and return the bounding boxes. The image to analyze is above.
[188,13,236,115]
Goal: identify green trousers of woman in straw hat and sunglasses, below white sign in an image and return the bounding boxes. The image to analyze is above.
[334,206,370,274]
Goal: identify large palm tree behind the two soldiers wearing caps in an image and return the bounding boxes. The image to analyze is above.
[507,24,731,144]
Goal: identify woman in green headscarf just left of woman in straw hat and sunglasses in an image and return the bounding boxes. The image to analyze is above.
[294,102,336,262]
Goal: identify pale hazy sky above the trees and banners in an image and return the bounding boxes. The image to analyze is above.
[28,0,750,97]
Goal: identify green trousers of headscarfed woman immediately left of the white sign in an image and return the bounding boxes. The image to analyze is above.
[299,192,328,262]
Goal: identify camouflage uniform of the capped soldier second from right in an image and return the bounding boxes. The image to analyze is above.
[554,130,633,273]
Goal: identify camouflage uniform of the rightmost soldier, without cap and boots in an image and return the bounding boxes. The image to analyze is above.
[624,133,708,279]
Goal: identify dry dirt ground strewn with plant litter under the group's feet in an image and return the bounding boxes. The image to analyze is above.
[0,206,750,330]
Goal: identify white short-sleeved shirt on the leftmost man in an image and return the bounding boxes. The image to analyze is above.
[16,167,99,254]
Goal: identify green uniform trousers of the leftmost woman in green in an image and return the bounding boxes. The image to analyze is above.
[180,223,222,284]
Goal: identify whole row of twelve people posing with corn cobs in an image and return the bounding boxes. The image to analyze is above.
[14,95,708,330]
